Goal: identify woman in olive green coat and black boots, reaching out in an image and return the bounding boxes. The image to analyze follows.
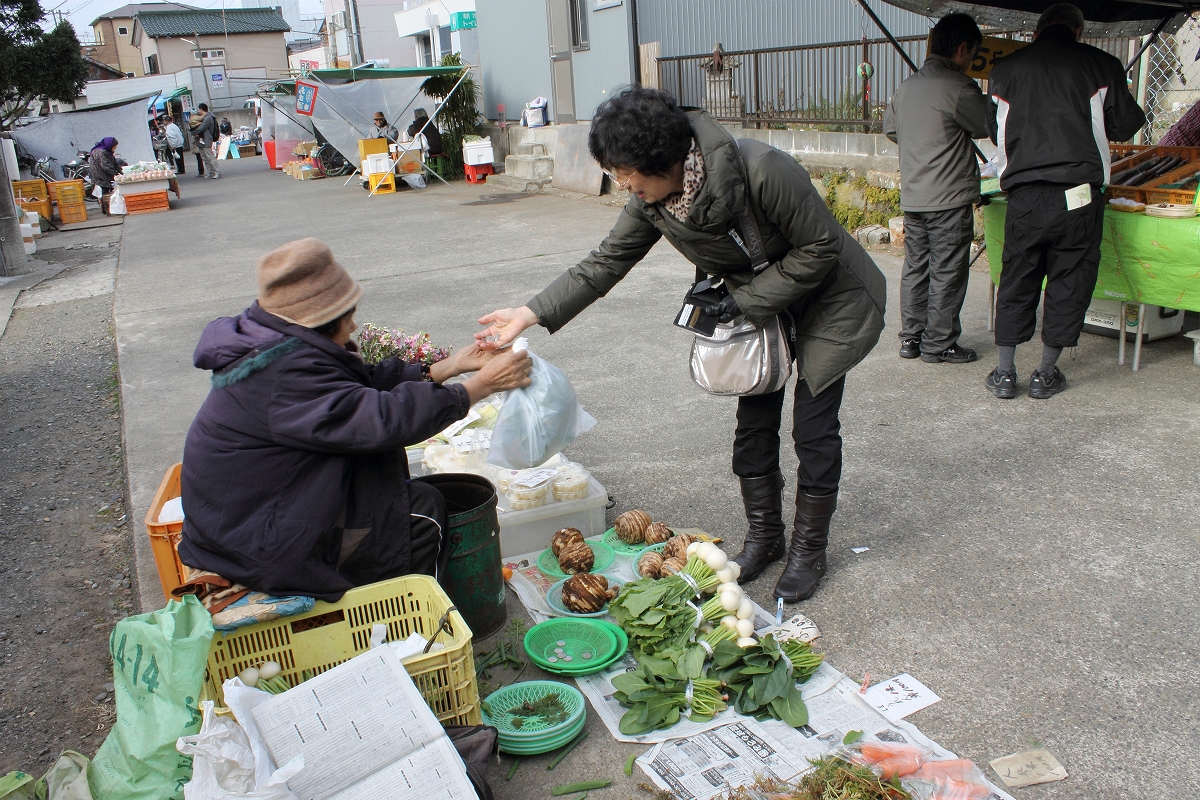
[476,88,887,602]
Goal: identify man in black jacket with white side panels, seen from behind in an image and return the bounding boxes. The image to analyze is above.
[985,2,1146,399]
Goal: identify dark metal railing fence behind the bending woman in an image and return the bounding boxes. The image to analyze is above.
[658,36,925,132]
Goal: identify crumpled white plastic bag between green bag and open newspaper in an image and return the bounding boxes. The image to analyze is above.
[175,700,304,800]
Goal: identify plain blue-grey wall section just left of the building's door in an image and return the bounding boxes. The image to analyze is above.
[475,0,554,120]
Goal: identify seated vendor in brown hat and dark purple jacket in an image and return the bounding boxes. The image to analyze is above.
[179,239,532,600]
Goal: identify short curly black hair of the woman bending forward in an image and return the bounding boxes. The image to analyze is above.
[588,86,692,176]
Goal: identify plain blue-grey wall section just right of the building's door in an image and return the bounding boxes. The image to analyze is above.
[571,2,635,120]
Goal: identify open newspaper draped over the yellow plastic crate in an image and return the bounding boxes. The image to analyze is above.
[251,648,475,800]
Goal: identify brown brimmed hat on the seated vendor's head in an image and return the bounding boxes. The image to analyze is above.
[258,237,362,327]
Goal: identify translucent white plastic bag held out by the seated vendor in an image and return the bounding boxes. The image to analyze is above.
[487,339,596,469]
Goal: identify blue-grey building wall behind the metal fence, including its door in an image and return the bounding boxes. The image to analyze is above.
[475,0,930,122]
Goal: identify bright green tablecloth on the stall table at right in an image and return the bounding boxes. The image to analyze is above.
[983,198,1200,311]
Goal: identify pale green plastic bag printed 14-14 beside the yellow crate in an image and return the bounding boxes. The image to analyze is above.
[88,595,212,800]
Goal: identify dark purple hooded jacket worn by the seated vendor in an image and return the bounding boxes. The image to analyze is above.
[179,302,470,601]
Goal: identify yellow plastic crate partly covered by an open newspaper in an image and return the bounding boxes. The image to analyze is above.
[204,575,481,724]
